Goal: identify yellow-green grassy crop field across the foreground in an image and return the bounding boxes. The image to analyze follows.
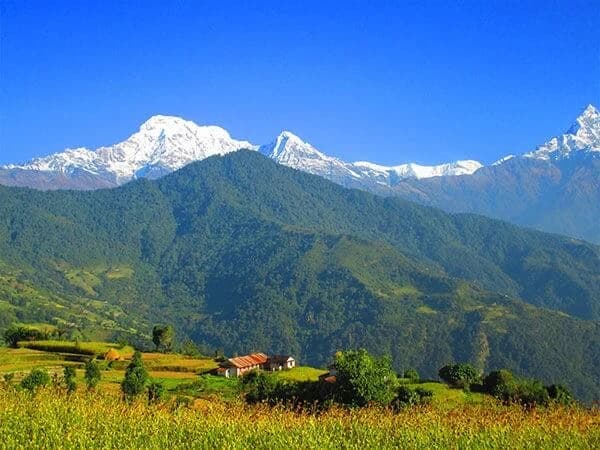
[0,388,600,449]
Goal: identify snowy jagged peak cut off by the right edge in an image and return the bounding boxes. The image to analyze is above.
[523,105,600,159]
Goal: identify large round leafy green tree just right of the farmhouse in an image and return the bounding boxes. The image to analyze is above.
[334,349,397,406]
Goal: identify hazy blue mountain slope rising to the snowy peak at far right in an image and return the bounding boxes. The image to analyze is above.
[392,105,600,243]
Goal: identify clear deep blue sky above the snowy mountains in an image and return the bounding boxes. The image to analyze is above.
[0,0,600,164]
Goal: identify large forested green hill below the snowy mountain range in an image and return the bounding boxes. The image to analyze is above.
[0,151,600,399]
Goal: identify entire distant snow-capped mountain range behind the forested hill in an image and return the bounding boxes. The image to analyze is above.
[0,105,600,243]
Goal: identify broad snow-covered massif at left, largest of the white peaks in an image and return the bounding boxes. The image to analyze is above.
[4,116,257,184]
